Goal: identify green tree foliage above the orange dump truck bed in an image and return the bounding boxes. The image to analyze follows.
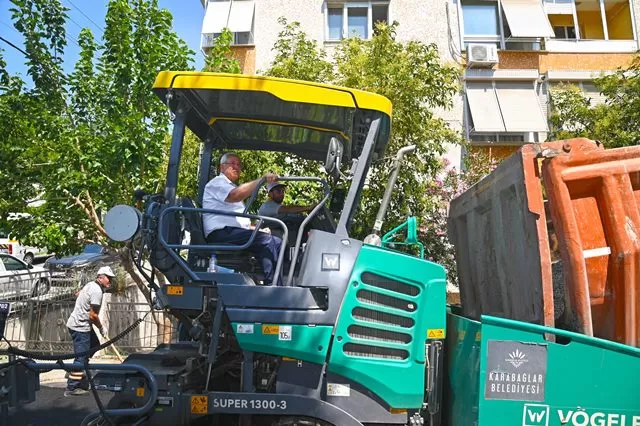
[549,57,640,148]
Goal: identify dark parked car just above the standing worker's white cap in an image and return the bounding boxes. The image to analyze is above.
[44,244,118,285]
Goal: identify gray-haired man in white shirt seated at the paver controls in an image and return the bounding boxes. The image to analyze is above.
[202,153,282,285]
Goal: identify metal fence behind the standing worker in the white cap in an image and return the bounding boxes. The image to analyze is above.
[0,266,177,356]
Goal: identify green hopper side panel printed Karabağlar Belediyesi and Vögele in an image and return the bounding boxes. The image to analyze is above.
[445,310,640,426]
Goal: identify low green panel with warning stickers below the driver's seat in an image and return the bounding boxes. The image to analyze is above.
[232,323,333,364]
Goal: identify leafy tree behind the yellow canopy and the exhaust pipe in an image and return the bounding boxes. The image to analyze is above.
[258,18,461,268]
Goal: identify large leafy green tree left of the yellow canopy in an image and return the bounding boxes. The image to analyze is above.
[0,0,193,254]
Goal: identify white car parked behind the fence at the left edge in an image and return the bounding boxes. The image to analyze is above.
[0,253,51,300]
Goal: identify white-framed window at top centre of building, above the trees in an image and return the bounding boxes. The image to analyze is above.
[325,1,389,41]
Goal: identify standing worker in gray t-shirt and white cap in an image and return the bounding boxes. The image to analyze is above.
[64,266,115,396]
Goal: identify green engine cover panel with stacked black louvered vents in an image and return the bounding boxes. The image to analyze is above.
[328,245,446,408]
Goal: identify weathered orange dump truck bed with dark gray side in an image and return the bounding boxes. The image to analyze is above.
[449,139,640,346]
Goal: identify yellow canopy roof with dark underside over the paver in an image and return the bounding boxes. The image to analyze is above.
[153,71,391,160]
